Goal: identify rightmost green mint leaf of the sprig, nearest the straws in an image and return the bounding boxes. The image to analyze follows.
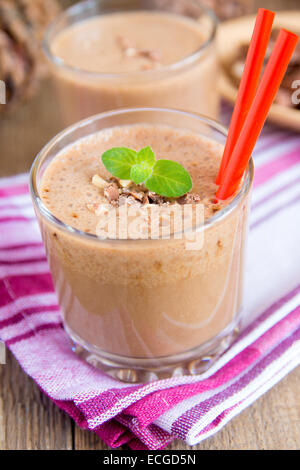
[145,160,193,197]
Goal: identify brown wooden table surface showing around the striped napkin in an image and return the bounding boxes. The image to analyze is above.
[0,0,300,450]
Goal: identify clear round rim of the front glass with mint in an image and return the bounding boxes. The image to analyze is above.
[29,106,254,244]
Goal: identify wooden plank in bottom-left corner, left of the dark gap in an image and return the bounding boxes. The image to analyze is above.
[0,353,73,450]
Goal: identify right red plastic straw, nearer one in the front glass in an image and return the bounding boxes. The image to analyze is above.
[217,29,298,199]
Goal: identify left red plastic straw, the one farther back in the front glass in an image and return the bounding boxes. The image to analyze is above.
[216,8,275,184]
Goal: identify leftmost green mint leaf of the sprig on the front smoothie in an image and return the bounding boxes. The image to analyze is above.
[102,147,137,180]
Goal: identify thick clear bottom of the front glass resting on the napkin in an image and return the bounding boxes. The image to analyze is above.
[65,324,239,383]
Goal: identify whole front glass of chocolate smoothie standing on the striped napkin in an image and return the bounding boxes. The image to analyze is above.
[30,108,253,382]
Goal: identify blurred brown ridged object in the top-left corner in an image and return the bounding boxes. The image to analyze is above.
[0,0,61,113]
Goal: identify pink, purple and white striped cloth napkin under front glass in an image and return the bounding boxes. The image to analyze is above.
[0,113,300,449]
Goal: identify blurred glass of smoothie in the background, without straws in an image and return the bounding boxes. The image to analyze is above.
[44,0,219,126]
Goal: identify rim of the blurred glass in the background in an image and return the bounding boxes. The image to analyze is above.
[42,0,219,80]
